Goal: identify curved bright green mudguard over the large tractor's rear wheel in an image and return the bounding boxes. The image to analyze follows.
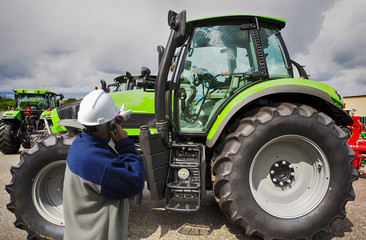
[206,79,353,147]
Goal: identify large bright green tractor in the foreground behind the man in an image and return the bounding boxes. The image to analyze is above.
[6,11,358,239]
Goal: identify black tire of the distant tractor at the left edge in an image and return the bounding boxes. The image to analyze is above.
[0,120,20,154]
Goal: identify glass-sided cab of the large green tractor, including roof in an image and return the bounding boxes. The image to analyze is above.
[173,19,293,133]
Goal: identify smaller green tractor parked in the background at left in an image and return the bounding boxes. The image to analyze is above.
[0,89,63,154]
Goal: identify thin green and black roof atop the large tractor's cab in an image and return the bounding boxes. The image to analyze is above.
[188,15,286,30]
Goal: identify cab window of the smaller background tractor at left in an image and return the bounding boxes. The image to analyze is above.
[17,94,56,111]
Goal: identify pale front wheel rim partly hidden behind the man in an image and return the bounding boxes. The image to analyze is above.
[32,160,66,226]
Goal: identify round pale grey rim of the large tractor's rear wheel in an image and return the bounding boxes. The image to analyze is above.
[249,135,330,219]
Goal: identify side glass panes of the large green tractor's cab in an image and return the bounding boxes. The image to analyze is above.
[177,25,289,132]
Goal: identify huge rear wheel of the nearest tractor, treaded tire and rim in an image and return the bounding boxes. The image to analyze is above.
[212,103,357,239]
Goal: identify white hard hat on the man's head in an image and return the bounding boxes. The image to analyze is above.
[78,90,119,126]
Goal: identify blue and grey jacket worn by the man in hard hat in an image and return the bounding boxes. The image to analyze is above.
[63,132,145,240]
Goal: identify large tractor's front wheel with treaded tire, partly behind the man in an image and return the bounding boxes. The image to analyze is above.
[6,134,75,239]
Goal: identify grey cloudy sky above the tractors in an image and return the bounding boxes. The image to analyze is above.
[0,0,366,98]
